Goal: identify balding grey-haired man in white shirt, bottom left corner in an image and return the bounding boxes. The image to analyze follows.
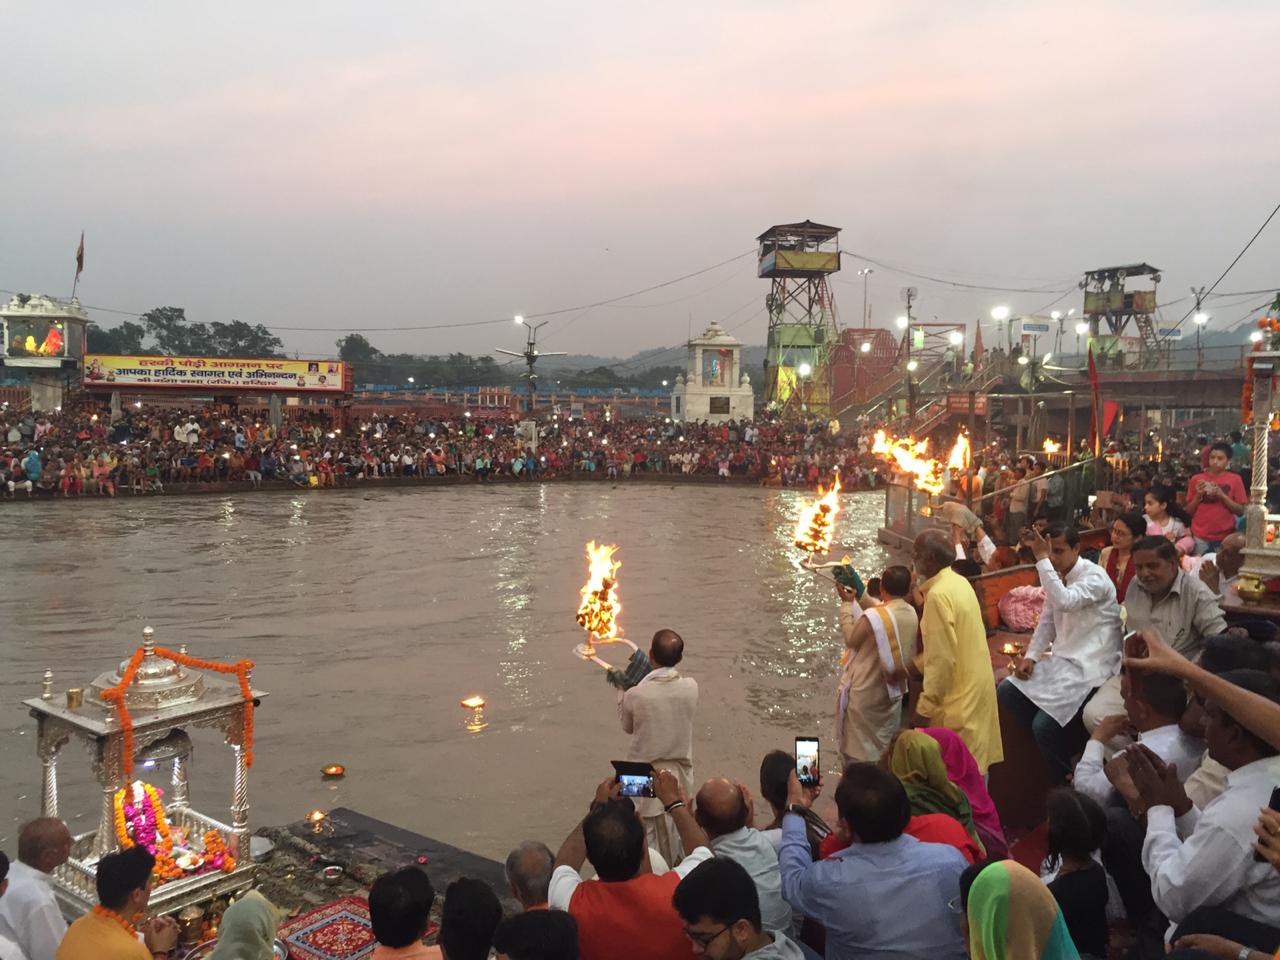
[0,817,72,960]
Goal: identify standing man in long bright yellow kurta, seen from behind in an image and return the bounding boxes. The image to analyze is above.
[911,530,1005,773]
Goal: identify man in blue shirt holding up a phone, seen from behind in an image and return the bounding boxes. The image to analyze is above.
[778,763,966,960]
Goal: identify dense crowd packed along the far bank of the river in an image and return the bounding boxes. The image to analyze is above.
[0,406,901,498]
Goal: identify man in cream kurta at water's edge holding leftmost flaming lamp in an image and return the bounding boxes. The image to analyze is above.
[618,630,698,867]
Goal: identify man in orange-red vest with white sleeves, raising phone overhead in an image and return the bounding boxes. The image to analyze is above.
[548,771,712,960]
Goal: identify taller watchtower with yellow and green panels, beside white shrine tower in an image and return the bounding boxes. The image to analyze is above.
[756,220,840,416]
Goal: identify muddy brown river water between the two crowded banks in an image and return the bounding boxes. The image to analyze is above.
[0,483,886,858]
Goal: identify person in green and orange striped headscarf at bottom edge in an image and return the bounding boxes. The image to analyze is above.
[960,860,1080,960]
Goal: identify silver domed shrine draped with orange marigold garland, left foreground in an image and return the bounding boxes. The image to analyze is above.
[24,627,266,916]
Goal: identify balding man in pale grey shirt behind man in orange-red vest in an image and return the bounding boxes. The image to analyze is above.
[694,777,792,936]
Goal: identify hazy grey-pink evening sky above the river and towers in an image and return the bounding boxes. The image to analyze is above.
[0,0,1280,356]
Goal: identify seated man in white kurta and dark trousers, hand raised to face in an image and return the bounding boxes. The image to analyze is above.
[996,525,1121,785]
